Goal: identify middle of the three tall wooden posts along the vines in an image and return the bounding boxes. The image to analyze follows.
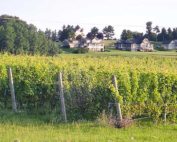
[58,72,67,122]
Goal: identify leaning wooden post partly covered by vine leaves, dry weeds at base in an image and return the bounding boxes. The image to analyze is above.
[112,75,122,121]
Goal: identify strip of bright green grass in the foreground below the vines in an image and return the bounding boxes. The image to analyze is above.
[0,112,177,142]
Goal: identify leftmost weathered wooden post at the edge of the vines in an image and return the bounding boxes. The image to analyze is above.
[8,67,17,112]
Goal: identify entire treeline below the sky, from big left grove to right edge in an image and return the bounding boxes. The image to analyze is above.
[0,15,177,56]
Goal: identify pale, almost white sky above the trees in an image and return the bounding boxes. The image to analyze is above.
[0,0,177,38]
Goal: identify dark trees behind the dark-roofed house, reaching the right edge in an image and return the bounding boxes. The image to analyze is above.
[120,22,177,43]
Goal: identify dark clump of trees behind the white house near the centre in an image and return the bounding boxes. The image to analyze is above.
[45,25,114,42]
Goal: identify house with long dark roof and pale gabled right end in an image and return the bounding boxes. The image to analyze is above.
[115,38,154,51]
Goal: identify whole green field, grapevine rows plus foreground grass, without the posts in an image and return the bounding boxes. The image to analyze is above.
[0,49,177,142]
